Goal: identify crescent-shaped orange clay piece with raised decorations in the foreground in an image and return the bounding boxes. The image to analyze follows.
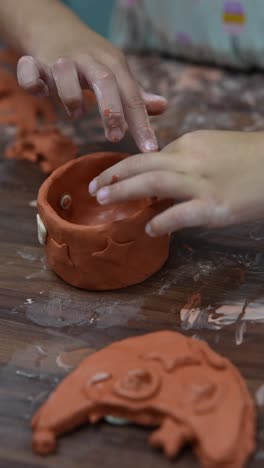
[32,331,256,468]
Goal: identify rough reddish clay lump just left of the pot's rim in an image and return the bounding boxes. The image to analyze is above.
[5,128,77,173]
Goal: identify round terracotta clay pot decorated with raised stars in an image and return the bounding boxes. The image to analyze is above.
[37,152,169,290]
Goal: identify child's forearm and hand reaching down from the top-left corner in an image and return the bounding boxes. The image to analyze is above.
[0,0,166,152]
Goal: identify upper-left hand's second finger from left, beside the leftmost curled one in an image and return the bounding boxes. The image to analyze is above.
[52,58,83,117]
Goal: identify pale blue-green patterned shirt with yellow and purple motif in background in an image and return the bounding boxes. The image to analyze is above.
[64,0,264,68]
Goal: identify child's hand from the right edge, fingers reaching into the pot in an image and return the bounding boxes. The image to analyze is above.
[89,131,264,236]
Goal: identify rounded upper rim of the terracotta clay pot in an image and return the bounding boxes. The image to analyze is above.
[37,151,153,232]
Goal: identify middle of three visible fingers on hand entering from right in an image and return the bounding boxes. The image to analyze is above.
[96,171,195,205]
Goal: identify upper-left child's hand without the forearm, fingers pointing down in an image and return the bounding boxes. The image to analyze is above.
[17,35,166,152]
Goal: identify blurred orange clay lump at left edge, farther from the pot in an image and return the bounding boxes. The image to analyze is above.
[0,68,57,131]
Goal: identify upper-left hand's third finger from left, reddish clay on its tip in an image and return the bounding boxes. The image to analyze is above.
[81,58,127,142]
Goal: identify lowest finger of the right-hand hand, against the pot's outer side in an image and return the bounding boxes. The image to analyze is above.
[146,200,215,237]
